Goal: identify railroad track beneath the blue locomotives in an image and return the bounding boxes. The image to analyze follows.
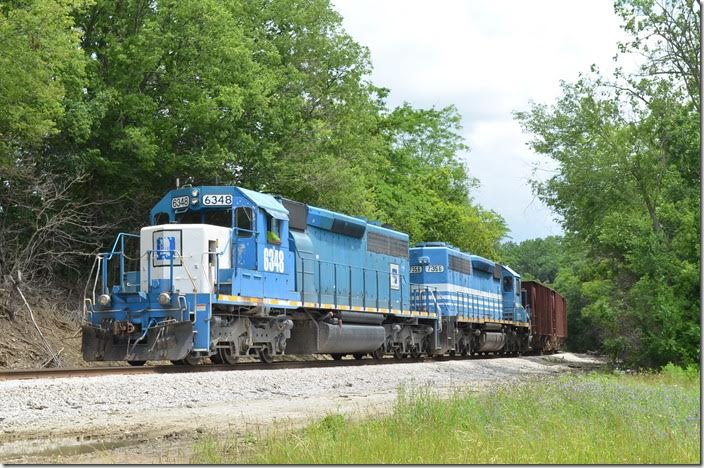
[0,355,500,381]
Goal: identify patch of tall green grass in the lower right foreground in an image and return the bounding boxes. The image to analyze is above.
[191,366,701,464]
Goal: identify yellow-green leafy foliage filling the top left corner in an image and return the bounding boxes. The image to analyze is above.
[0,0,86,165]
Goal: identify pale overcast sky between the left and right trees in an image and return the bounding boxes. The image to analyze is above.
[333,0,624,241]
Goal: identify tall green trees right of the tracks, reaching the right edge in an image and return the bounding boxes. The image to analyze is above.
[516,0,701,366]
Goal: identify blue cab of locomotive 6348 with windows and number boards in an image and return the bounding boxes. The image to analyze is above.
[148,186,295,299]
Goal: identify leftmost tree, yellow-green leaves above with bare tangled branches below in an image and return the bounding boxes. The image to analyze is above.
[0,0,105,292]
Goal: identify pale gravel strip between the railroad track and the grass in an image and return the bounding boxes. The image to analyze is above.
[0,353,600,463]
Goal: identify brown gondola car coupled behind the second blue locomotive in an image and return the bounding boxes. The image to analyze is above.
[521,281,567,353]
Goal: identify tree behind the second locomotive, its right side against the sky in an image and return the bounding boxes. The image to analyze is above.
[371,104,507,258]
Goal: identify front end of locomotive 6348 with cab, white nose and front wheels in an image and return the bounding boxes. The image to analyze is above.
[83,186,297,363]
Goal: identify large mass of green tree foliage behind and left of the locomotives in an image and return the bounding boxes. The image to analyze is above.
[0,0,506,286]
